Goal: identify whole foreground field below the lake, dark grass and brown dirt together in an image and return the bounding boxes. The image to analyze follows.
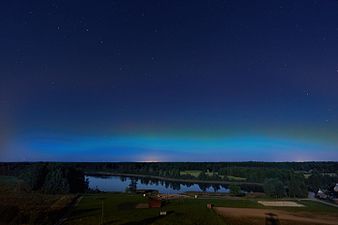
[64,193,338,225]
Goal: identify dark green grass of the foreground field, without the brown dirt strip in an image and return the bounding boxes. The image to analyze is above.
[64,193,338,225]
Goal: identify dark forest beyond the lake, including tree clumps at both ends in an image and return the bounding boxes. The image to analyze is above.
[0,162,338,197]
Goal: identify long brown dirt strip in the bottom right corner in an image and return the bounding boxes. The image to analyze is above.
[214,207,338,225]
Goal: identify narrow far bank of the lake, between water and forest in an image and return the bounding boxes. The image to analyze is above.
[86,172,263,186]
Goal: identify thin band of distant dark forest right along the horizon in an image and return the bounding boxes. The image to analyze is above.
[0,161,338,173]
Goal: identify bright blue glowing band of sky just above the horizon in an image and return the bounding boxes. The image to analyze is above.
[5,135,338,161]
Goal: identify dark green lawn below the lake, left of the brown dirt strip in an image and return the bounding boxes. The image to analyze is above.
[65,193,225,225]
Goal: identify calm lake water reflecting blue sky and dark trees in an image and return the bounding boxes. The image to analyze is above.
[86,176,229,194]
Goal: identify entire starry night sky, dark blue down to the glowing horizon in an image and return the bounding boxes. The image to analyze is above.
[0,0,338,161]
